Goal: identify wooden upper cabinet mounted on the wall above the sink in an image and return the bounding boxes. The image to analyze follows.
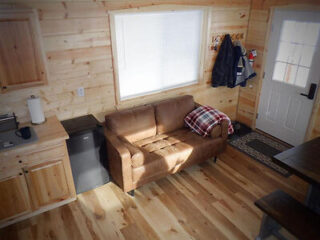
[0,9,47,92]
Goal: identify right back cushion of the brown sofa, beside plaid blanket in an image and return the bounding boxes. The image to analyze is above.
[153,95,195,134]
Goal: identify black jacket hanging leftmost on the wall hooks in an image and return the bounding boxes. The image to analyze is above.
[211,34,235,87]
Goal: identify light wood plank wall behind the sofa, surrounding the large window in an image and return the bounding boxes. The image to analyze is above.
[0,0,250,122]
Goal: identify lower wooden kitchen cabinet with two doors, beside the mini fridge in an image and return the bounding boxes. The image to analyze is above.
[0,117,76,228]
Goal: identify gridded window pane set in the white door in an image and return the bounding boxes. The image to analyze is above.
[273,20,320,88]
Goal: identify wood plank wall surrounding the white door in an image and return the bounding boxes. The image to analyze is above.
[237,0,320,139]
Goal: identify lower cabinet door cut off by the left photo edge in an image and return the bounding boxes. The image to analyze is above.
[0,173,31,221]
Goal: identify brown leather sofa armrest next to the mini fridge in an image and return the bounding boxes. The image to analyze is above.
[104,127,132,192]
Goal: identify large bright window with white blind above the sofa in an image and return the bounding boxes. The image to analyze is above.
[111,7,208,100]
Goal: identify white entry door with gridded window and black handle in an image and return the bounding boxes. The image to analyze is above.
[256,9,320,146]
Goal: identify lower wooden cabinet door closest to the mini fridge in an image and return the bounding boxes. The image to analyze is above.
[25,160,70,209]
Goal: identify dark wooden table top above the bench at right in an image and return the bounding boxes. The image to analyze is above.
[272,137,320,186]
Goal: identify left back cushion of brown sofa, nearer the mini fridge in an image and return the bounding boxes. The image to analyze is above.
[105,105,157,143]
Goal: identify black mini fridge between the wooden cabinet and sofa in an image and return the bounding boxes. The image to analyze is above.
[62,115,110,194]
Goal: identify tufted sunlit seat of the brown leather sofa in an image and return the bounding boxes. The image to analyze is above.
[133,128,223,182]
